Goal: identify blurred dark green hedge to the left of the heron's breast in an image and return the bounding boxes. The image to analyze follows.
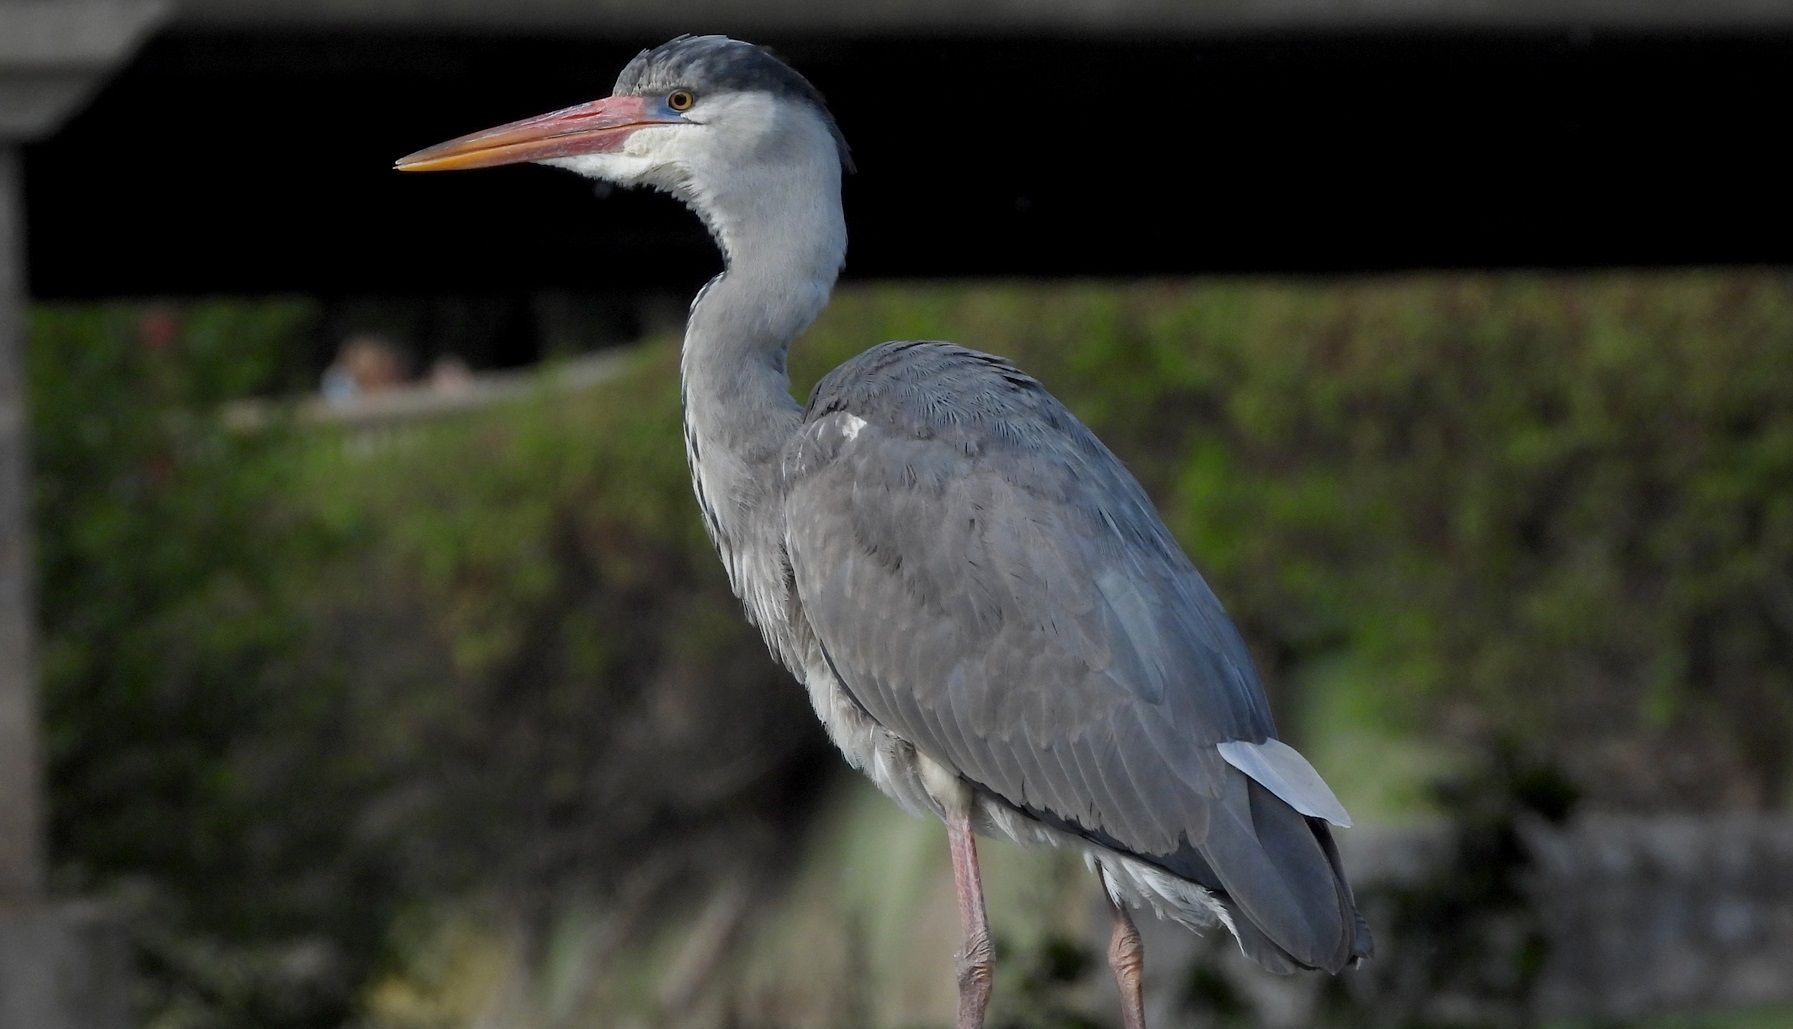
[30,305,821,1027]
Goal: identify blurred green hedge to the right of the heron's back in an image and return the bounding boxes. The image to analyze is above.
[801,272,1793,805]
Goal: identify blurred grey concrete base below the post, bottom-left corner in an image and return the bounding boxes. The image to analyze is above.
[0,904,131,1029]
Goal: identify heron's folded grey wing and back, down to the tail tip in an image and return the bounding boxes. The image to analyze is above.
[784,342,1368,970]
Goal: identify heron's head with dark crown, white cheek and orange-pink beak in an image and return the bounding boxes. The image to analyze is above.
[396,36,846,215]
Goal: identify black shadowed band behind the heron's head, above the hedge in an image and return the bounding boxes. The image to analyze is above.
[27,32,1793,298]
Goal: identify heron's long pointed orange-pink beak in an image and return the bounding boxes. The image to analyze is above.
[393,97,681,172]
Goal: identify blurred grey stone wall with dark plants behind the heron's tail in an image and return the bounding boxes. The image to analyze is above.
[1148,812,1793,1025]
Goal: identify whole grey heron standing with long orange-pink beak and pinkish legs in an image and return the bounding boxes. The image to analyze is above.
[396,36,1370,1027]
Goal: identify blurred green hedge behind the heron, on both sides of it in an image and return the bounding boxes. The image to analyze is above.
[30,272,1793,1025]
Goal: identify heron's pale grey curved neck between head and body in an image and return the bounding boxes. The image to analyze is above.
[680,143,846,588]
